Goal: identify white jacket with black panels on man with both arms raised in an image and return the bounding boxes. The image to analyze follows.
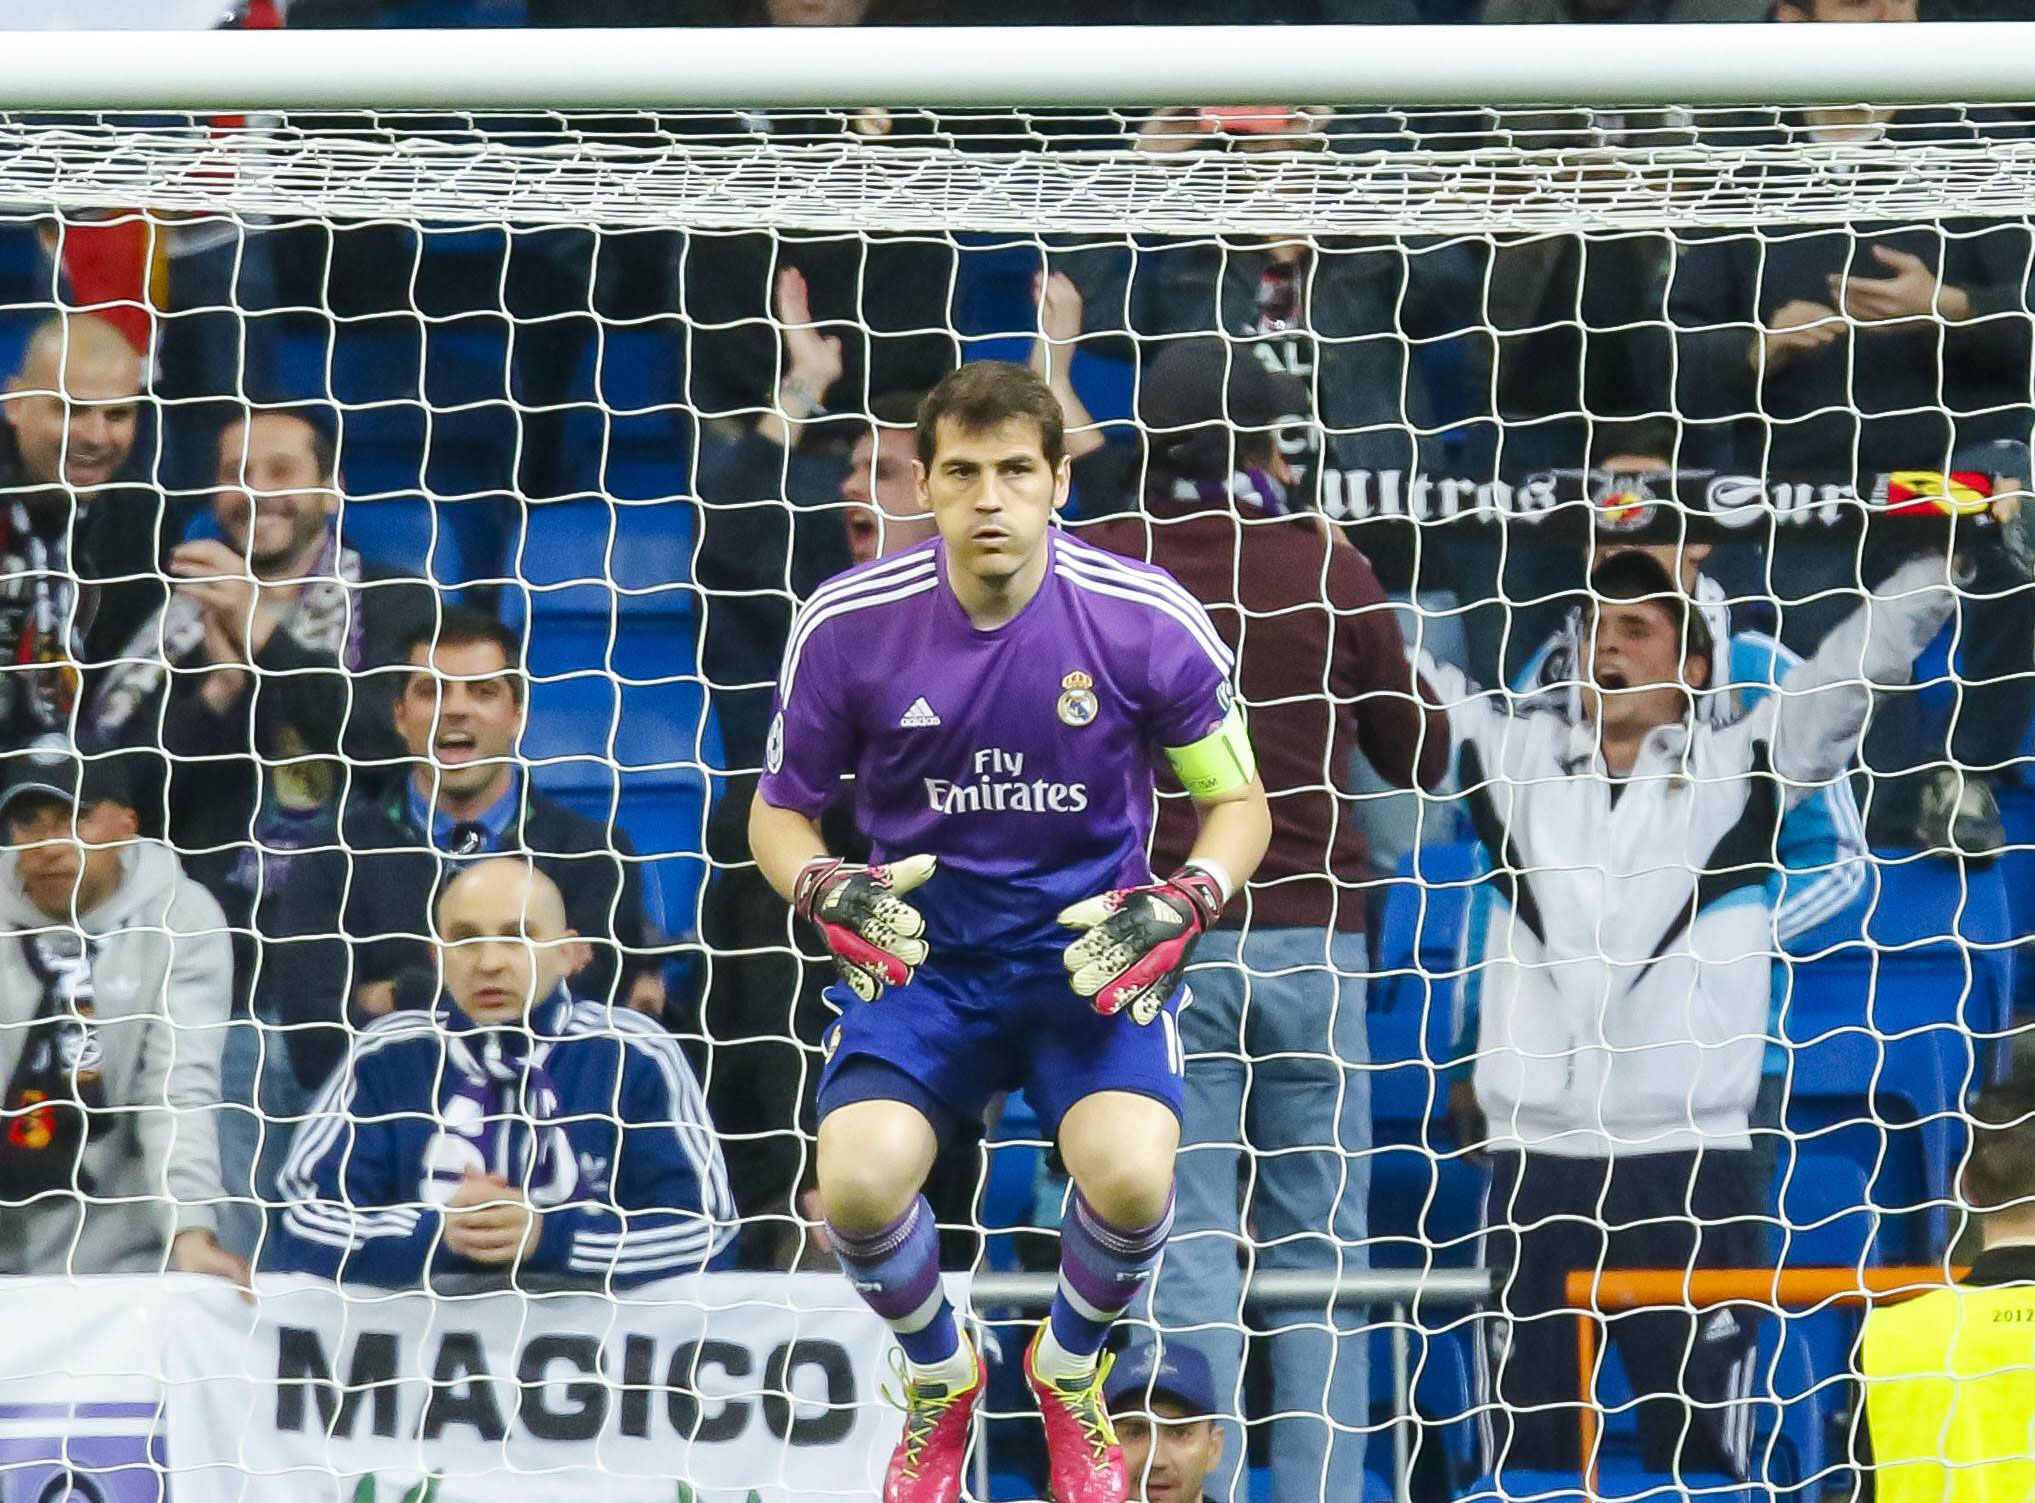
[1422,557,1954,1157]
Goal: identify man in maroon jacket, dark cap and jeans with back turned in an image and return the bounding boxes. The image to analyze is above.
[1081,340,1449,1503]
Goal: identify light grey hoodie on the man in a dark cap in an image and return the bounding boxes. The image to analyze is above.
[0,840,234,1273]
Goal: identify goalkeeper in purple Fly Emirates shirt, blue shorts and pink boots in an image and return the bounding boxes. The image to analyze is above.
[749,362,1272,1503]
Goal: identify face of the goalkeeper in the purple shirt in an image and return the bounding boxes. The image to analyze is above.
[918,417,1070,588]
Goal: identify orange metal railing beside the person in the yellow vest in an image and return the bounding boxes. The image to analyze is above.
[1554,1263,1964,1487]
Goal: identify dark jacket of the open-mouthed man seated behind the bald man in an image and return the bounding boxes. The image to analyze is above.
[258,787,657,1090]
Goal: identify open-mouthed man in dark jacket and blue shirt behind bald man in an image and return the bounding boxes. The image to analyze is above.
[263,606,663,1090]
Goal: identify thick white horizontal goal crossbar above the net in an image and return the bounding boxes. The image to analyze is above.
[0,22,2027,110]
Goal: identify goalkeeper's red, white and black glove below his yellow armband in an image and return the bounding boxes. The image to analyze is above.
[1060,866,1227,1023]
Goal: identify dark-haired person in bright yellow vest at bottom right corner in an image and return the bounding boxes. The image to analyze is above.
[1860,1084,2035,1503]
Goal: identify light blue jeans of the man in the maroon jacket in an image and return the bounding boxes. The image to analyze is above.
[1152,929,1372,1503]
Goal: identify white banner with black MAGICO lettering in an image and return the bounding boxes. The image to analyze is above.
[0,1273,967,1503]
